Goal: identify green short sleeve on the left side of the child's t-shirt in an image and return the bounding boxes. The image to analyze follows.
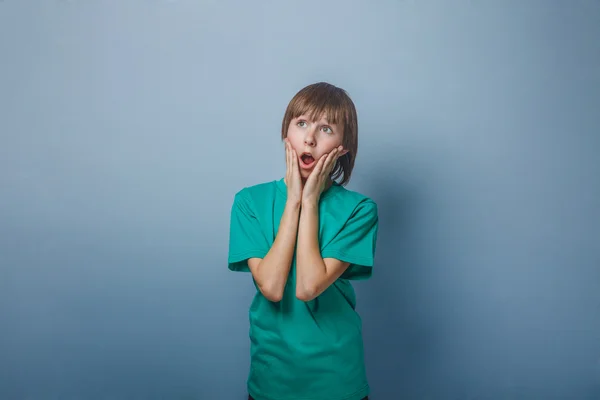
[228,191,269,272]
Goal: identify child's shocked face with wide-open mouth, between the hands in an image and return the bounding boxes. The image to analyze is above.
[287,115,348,179]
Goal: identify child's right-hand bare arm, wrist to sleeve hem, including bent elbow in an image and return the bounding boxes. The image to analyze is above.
[296,202,350,301]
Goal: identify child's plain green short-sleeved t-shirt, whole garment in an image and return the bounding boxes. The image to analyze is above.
[228,179,378,400]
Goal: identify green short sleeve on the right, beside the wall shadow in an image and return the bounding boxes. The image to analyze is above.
[321,200,379,280]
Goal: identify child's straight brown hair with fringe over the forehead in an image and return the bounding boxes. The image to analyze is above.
[281,82,358,186]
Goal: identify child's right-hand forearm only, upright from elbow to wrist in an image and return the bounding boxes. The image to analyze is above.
[296,202,326,299]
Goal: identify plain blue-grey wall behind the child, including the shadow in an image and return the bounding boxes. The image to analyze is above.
[0,0,600,400]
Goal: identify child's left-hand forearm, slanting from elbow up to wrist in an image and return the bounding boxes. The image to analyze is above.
[255,201,300,301]
